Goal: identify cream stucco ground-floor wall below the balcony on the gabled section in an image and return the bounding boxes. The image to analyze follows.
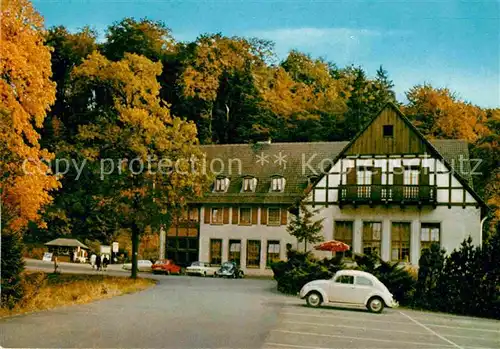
[310,205,481,264]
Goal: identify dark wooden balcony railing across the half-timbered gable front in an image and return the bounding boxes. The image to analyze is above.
[339,184,436,204]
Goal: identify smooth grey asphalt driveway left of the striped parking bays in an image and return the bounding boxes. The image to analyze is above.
[0,276,282,349]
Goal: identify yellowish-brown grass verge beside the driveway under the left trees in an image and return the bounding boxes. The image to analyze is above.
[0,272,156,317]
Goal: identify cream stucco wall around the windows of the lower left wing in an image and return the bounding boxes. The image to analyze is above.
[199,207,297,275]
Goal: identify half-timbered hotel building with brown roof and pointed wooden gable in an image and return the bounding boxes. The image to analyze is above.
[166,104,487,274]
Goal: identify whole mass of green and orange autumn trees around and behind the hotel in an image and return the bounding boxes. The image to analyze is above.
[0,0,500,253]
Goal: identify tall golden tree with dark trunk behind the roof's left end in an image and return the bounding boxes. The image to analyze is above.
[177,34,269,142]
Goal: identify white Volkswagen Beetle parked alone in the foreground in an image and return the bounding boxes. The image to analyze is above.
[299,270,398,313]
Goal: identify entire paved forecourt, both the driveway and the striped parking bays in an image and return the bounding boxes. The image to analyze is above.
[0,267,500,349]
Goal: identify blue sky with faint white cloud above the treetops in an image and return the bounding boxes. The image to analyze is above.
[33,0,500,107]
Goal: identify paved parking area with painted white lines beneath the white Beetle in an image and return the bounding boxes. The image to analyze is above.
[264,300,500,349]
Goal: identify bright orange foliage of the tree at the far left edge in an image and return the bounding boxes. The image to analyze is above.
[0,0,59,232]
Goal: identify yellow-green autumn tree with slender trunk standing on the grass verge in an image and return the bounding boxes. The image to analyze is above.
[73,52,207,277]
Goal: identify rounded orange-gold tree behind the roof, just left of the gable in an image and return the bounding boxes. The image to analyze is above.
[254,51,346,140]
